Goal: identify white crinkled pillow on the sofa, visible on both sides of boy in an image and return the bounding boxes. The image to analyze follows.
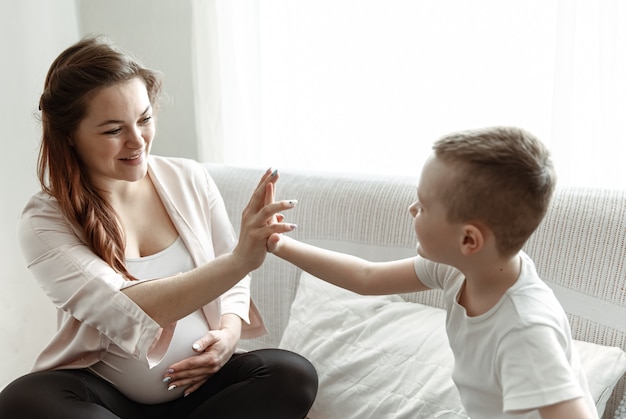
[279,273,626,419]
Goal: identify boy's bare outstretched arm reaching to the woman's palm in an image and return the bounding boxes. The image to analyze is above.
[267,234,428,295]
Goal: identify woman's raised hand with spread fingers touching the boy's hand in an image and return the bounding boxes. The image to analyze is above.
[233,169,296,271]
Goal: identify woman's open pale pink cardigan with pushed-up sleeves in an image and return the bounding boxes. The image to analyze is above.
[18,156,267,371]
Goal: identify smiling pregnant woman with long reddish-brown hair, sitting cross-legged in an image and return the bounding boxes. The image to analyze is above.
[0,37,317,419]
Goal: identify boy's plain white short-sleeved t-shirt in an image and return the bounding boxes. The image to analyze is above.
[415,252,597,419]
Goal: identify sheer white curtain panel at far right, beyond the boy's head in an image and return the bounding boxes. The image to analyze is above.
[549,0,626,188]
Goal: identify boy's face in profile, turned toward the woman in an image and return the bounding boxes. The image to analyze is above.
[409,155,461,264]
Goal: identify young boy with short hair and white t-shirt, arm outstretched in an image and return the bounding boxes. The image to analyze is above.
[268,127,598,419]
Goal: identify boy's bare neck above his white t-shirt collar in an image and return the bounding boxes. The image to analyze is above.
[459,254,522,316]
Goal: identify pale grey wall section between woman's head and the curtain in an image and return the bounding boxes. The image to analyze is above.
[76,0,198,159]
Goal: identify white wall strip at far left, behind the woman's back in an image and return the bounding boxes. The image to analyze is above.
[0,0,78,388]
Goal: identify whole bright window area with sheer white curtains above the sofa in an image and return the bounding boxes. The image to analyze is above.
[205,0,626,187]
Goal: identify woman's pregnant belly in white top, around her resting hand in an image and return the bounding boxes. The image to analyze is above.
[90,311,209,404]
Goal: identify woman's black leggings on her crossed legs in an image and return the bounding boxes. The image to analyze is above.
[0,349,318,419]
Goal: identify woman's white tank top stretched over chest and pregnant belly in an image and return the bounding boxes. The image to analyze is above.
[89,237,209,404]
